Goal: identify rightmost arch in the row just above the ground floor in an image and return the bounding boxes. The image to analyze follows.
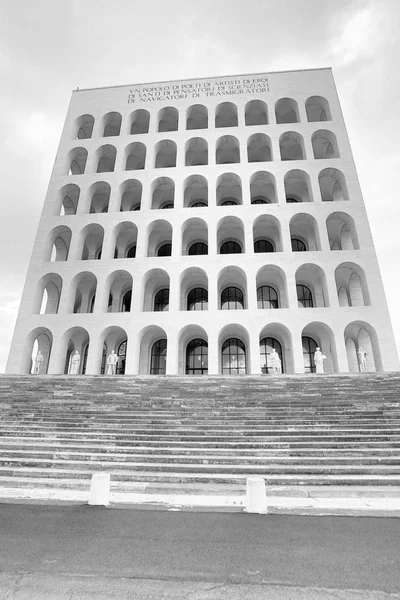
[335,262,371,306]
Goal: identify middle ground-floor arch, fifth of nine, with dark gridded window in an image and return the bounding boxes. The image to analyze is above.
[178,325,208,375]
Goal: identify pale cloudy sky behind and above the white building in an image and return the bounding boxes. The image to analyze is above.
[0,0,400,373]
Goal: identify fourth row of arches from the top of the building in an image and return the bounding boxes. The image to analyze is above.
[44,212,360,262]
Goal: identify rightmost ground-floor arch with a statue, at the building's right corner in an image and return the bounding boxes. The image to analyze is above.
[344,320,383,373]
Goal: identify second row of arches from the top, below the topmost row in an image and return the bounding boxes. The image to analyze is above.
[64,129,340,175]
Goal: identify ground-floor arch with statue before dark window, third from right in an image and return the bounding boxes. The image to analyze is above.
[259,323,294,374]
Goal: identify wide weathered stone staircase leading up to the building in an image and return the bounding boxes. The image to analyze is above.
[0,373,400,496]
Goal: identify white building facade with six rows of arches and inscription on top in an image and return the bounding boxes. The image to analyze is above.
[7,69,399,374]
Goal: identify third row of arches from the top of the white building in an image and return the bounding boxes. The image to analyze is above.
[54,169,349,216]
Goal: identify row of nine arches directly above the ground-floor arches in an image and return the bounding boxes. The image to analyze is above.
[33,262,371,314]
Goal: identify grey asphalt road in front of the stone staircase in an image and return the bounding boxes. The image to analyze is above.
[0,504,400,600]
